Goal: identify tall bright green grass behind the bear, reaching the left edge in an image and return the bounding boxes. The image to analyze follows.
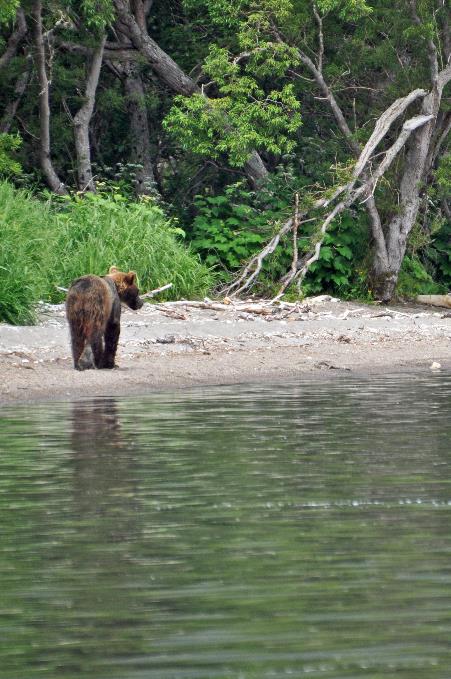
[0,182,213,325]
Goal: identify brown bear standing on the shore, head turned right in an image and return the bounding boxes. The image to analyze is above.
[66,266,143,370]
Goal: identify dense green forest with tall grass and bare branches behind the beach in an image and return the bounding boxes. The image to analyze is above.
[0,0,451,322]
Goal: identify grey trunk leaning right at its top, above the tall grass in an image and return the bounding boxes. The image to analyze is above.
[74,36,105,191]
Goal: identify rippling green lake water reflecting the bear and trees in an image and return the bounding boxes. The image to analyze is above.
[0,375,451,679]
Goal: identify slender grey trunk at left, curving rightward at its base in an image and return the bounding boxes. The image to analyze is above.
[31,0,67,195]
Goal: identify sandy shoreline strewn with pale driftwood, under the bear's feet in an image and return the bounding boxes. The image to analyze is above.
[0,297,451,403]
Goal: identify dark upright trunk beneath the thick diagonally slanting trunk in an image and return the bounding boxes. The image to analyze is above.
[124,64,155,196]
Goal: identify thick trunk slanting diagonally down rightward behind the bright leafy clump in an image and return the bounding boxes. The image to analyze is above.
[113,0,268,187]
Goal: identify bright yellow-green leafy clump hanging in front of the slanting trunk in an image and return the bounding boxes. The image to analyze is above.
[164,35,301,167]
